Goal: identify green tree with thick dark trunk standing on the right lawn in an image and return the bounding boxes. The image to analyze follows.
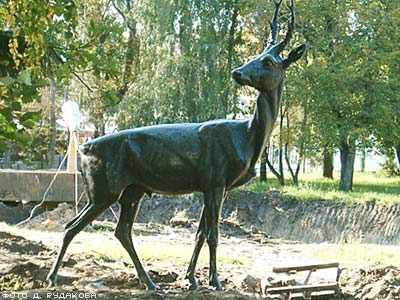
[284,0,398,191]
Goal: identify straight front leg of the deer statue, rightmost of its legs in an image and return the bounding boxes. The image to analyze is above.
[204,187,225,291]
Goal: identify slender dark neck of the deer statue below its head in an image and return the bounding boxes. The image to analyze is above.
[249,81,283,166]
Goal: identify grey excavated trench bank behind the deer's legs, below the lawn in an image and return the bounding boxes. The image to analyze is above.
[137,191,400,245]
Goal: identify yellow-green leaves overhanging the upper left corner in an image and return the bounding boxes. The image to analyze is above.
[0,0,77,152]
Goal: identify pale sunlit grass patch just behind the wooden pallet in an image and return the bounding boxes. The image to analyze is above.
[313,242,400,266]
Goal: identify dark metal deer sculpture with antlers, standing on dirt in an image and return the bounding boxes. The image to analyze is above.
[47,0,306,290]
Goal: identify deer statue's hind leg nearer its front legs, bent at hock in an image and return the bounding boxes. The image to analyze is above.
[115,186,156,290]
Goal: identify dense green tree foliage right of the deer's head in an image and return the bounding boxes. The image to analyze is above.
[256,0,400,190]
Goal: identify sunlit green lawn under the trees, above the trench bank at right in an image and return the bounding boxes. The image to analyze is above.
[241,173,400,205]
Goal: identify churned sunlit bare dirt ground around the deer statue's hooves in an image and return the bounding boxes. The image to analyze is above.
[0,211,400,300]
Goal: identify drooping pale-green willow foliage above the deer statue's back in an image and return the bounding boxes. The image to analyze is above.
[118,0,240,128]
